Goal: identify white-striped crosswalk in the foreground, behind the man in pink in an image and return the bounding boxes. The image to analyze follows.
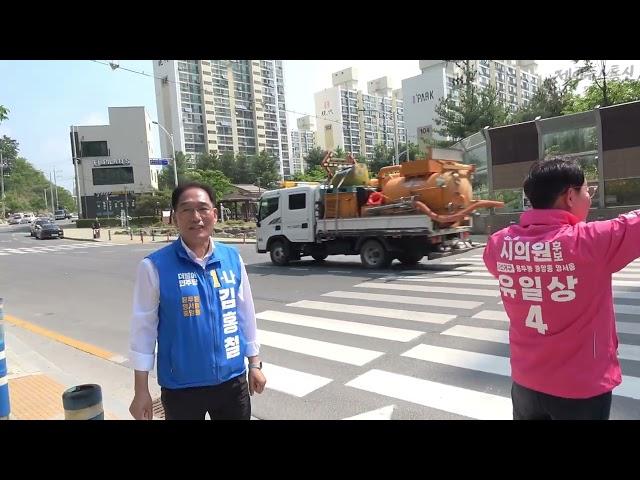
[256,254,640,419]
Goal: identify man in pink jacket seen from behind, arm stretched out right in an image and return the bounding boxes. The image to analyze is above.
[484,158,640,420]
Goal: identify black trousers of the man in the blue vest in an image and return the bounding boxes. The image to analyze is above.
[160,374,251,420]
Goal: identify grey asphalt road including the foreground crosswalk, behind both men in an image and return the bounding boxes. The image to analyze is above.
[0,225,640,419]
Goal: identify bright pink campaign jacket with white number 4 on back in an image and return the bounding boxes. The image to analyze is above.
[484,209,640,398]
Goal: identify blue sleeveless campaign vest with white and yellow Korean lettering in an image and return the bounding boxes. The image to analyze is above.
[147,238,246,389]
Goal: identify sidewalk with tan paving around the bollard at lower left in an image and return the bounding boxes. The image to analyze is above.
[4,319,160,420]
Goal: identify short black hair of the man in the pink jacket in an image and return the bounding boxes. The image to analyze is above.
[523,157,584,208]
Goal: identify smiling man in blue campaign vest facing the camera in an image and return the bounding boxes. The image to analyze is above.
[129,183,266,420]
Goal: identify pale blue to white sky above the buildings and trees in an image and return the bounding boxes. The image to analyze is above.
[0,60,640,191]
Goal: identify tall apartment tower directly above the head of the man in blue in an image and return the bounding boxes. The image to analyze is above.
[153,60,292,175]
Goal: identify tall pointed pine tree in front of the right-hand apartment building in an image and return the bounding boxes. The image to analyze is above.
[435,60,508,141]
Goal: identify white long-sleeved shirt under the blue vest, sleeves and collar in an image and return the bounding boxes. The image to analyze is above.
[129,239,260,372]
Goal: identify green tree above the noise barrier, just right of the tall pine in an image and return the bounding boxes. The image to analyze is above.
[509,77,574,123]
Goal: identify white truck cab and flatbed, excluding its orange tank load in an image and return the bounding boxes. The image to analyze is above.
[256,185,471,268]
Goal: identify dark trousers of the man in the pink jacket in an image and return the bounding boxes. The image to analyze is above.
[511,382,611,420]
